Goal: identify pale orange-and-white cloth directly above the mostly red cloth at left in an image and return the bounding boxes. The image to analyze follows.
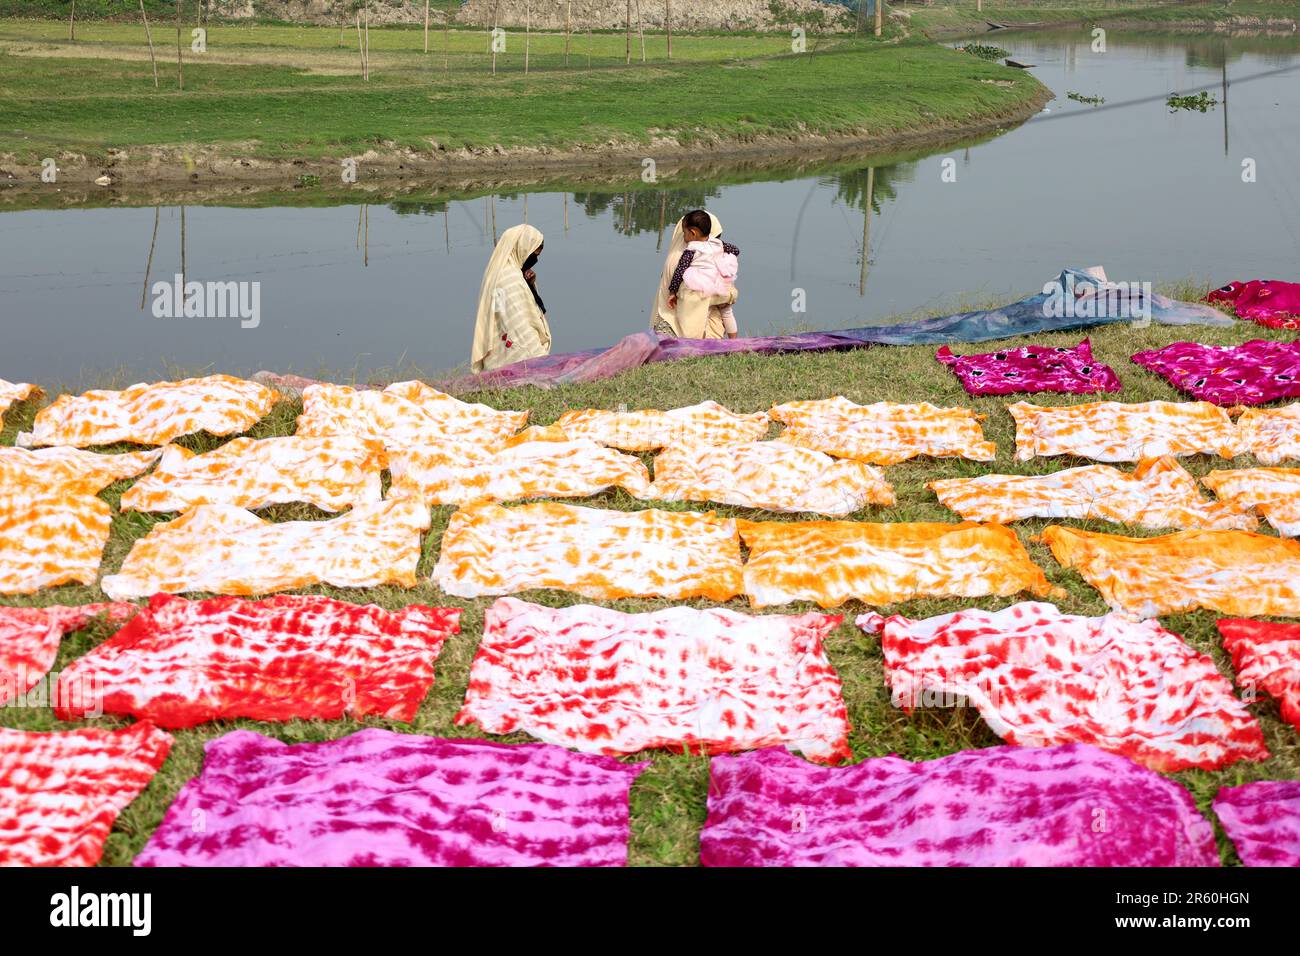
[101,499,429,601]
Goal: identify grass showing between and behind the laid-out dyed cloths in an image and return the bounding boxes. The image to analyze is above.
[0,289,1300,865]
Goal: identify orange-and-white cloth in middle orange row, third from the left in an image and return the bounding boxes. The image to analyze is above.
[389,425,650,505]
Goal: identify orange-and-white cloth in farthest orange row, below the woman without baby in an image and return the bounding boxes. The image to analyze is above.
[298,381,528,449]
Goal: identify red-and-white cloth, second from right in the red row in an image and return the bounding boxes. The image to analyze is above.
[858,602,1269,773]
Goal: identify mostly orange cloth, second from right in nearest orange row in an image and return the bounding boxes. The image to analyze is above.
[736,520,1053,607]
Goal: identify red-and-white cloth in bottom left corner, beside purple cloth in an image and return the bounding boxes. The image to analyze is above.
[0,722,172,866]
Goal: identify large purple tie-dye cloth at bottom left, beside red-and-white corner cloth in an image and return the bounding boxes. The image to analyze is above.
[135,730,646,866]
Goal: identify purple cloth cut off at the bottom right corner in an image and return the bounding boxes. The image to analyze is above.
[1214,780,1300,866]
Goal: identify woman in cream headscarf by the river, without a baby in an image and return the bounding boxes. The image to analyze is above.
[471,225,551,372]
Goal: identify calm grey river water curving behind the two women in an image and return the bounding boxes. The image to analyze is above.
[0,27,1300,388]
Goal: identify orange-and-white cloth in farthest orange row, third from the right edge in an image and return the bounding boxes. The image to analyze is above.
[768,395,997,464]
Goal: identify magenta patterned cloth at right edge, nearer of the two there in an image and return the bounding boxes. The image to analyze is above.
[1132,338,1300,405]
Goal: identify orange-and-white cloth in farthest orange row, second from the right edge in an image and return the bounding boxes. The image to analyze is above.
[1006,402,1240,462]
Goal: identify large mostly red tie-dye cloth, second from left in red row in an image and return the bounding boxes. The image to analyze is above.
[55,594,460,728]
